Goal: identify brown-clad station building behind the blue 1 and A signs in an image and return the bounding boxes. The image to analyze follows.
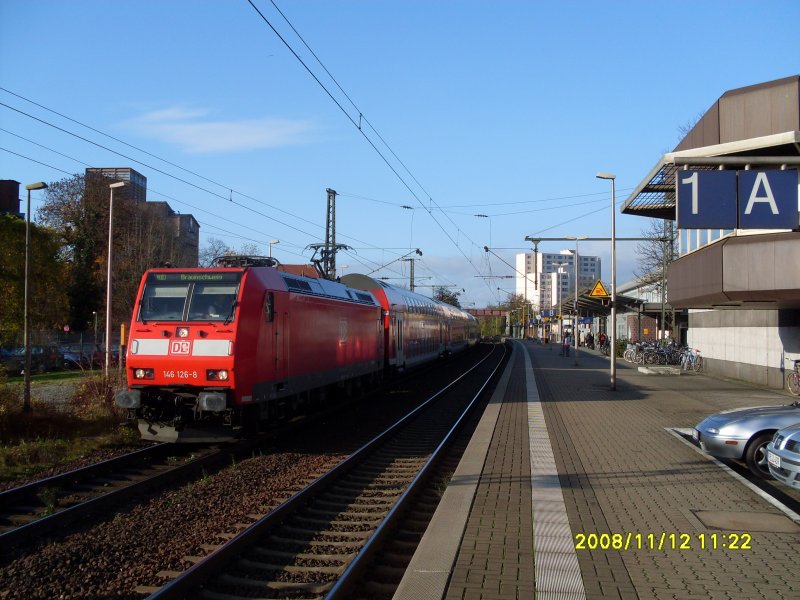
[622,75,800,388]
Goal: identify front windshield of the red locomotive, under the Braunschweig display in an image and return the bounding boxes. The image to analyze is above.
[138,273,242,323]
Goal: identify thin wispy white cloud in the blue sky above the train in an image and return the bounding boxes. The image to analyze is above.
[126,106,315,154]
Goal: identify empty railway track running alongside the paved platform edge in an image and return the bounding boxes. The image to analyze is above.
[146,340,505,600]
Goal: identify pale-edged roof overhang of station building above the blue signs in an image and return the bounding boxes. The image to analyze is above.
[621,131,800,220]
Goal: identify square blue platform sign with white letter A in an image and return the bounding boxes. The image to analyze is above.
[739,170,800,229]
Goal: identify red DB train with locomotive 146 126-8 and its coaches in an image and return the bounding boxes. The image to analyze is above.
[116,259,478,442]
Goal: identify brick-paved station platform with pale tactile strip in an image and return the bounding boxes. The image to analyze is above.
[395,341,800,599]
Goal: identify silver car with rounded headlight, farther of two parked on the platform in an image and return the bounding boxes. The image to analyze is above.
[694,402,800,479]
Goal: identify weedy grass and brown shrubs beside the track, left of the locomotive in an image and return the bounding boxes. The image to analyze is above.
[0,373,139,488]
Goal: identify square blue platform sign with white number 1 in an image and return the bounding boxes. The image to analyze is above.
[676,171,737,229]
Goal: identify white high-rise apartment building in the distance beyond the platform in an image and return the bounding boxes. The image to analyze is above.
[515,250,601,310]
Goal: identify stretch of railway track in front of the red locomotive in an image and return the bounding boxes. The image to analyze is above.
[0,444,227,548]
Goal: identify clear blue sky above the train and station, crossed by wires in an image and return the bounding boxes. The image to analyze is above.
[0,0,800,306]
